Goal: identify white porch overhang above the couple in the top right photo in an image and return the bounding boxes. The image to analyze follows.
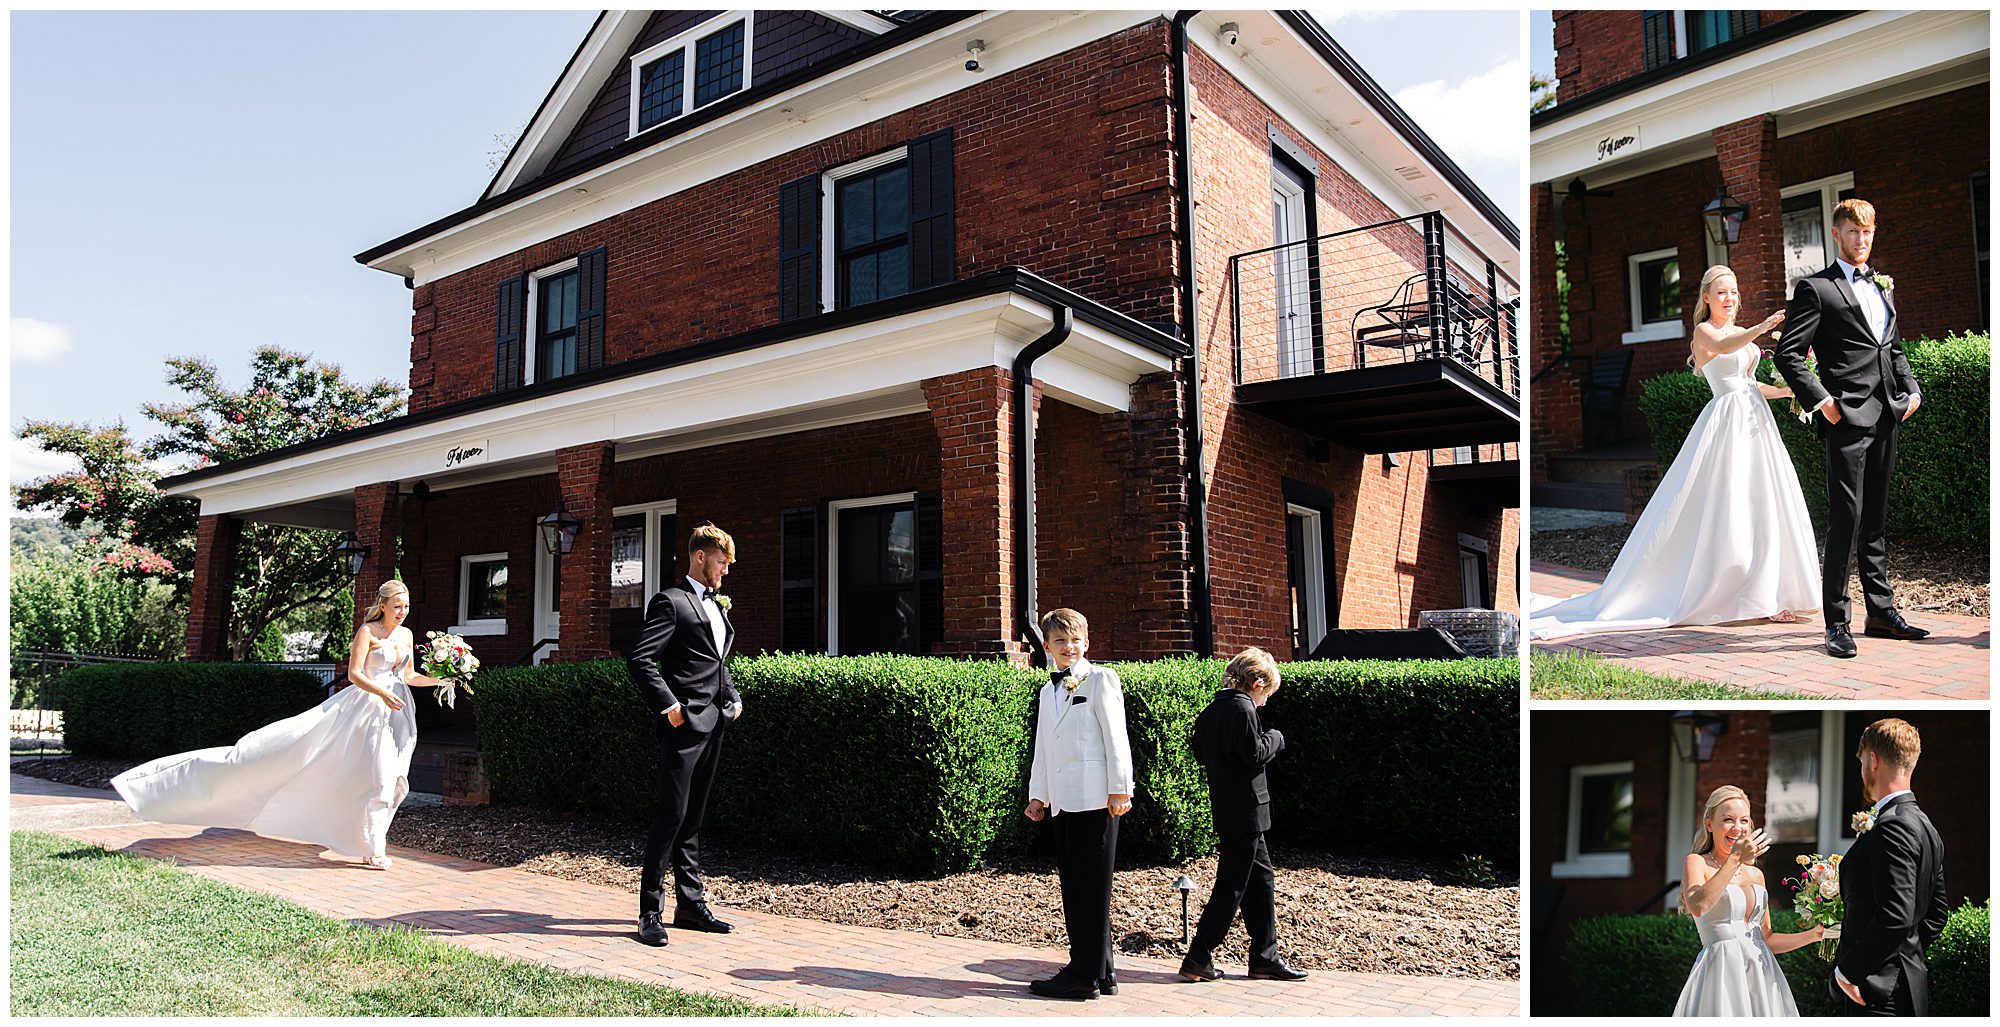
[1528,10,1992,190]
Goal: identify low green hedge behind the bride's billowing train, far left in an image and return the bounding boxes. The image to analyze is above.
[60,663,326,759]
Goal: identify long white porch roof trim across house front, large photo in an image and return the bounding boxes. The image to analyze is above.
[164,292,1172,523]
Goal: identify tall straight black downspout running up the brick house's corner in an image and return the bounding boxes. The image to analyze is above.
[1174,10,1216,659]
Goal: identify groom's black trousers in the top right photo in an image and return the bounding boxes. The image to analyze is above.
[1820,404,1898,619]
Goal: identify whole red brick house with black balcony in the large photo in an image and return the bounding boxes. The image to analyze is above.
[162,10,1520,715]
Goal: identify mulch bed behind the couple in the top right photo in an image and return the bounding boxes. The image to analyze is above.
[1528,515,1992,617]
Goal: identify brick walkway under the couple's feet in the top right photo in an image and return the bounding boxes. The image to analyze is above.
[1528,563,1992,701]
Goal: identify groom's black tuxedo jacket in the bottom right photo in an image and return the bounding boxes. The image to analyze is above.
[1834,795,1950,1017]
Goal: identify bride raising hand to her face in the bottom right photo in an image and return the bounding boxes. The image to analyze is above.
[1674,785,1826,1017]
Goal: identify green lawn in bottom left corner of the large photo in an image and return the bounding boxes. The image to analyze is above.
[10,831,816,1017]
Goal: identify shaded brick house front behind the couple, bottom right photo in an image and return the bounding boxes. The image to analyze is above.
[1526,705,1992,1003]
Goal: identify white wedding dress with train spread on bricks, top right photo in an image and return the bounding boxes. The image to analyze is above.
[1528,346,1820,639]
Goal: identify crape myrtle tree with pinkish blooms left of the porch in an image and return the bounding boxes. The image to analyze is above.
[14,346,404,659]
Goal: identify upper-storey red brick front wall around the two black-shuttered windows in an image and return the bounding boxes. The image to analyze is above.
[410,20,1176,412]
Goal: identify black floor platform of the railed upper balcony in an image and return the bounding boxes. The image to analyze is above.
[1236,358,1520,454]
